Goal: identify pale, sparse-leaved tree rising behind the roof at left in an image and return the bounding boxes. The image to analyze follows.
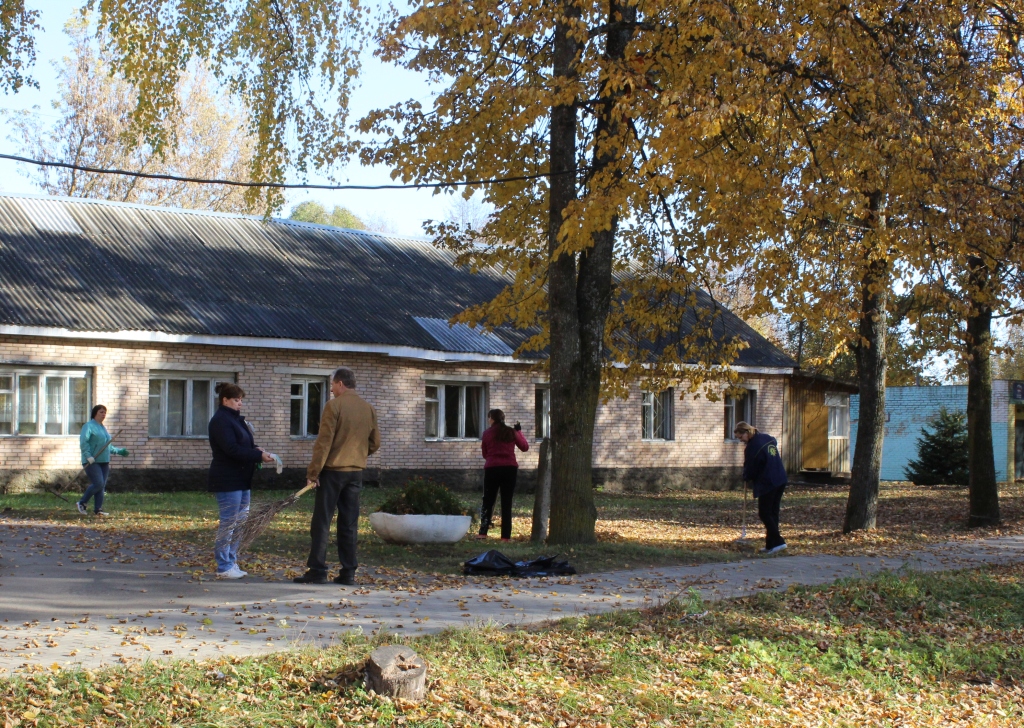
[12,16,260,212]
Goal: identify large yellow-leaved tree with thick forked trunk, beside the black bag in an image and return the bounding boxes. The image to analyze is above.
[361,0,819,543]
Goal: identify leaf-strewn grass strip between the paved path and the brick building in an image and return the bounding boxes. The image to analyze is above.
[0,483,1024,577]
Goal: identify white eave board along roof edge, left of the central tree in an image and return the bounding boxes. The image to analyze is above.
[0,325,534,365]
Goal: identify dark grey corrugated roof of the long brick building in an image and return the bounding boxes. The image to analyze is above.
[0,194,794,367]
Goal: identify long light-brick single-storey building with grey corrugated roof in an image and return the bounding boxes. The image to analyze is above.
[0,196,815,490]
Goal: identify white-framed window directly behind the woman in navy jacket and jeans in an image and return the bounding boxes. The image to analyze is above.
[150,373,229,437]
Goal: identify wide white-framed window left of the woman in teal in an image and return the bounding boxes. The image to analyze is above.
[0,370,90,436]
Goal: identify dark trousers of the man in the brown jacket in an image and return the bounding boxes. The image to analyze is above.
[306,470,362,574]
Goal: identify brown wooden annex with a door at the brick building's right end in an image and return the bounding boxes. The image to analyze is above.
[780,372,858,478]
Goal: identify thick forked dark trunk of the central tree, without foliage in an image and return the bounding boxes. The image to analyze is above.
[548,0,636,544]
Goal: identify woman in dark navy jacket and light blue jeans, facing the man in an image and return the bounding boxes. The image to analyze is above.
[207,382,273,579]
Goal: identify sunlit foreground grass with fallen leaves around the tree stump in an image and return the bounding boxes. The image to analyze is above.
[0,564,1024,728]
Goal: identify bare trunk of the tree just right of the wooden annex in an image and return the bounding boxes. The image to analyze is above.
[843,192,889,533]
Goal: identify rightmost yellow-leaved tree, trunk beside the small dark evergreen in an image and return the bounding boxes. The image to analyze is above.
[897,2,1024,526]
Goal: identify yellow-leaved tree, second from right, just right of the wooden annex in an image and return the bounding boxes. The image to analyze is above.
[733,0,1019,531]
